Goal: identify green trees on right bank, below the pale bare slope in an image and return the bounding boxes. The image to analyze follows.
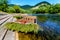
[32,4,60,14]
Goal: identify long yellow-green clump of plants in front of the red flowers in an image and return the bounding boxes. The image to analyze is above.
[5,22,39,33]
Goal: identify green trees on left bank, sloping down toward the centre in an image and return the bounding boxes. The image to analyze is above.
[0,0,28,13]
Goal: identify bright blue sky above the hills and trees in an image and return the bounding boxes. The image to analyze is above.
[8,0,60,6]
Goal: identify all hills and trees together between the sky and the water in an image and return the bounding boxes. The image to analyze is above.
[0,0,60,14]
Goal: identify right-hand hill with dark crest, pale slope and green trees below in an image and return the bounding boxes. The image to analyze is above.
[31,1,60,14]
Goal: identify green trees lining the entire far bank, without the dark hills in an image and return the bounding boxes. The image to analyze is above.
[0,0,60,14]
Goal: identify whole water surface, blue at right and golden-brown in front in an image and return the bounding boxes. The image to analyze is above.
[19,15,60,40]
